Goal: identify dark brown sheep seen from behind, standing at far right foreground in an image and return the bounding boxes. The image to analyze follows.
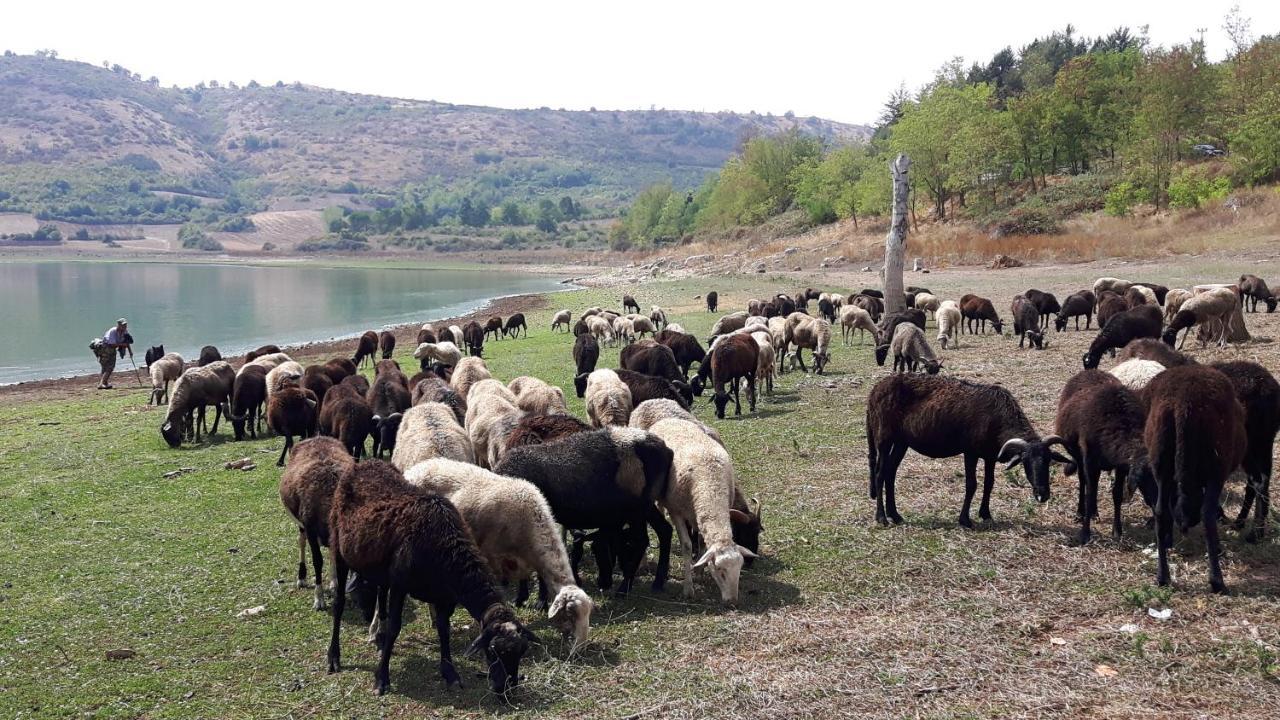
[1143,363,1248,593]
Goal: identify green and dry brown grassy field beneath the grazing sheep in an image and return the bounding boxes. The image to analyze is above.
[0,266,1280,717]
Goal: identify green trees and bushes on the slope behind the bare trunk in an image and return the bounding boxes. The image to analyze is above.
[611,18,1280,249]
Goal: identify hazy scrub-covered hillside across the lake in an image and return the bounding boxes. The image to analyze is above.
[0,55,869,210]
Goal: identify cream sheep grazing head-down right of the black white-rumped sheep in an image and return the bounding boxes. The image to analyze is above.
[650,419,755,605]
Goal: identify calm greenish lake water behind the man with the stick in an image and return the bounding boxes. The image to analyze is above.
[0,261,564,384]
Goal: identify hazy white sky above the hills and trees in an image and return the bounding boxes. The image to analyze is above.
[0,0,1280,123]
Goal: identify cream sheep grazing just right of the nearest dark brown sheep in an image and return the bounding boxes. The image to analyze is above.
[404,459,595,647]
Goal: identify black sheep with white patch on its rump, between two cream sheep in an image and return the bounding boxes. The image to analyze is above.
[494,422,672,594]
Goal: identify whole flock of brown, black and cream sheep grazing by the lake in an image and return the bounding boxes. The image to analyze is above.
[132,275,1280,693]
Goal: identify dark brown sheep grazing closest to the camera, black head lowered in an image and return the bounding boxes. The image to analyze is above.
[328,460,538,694]
